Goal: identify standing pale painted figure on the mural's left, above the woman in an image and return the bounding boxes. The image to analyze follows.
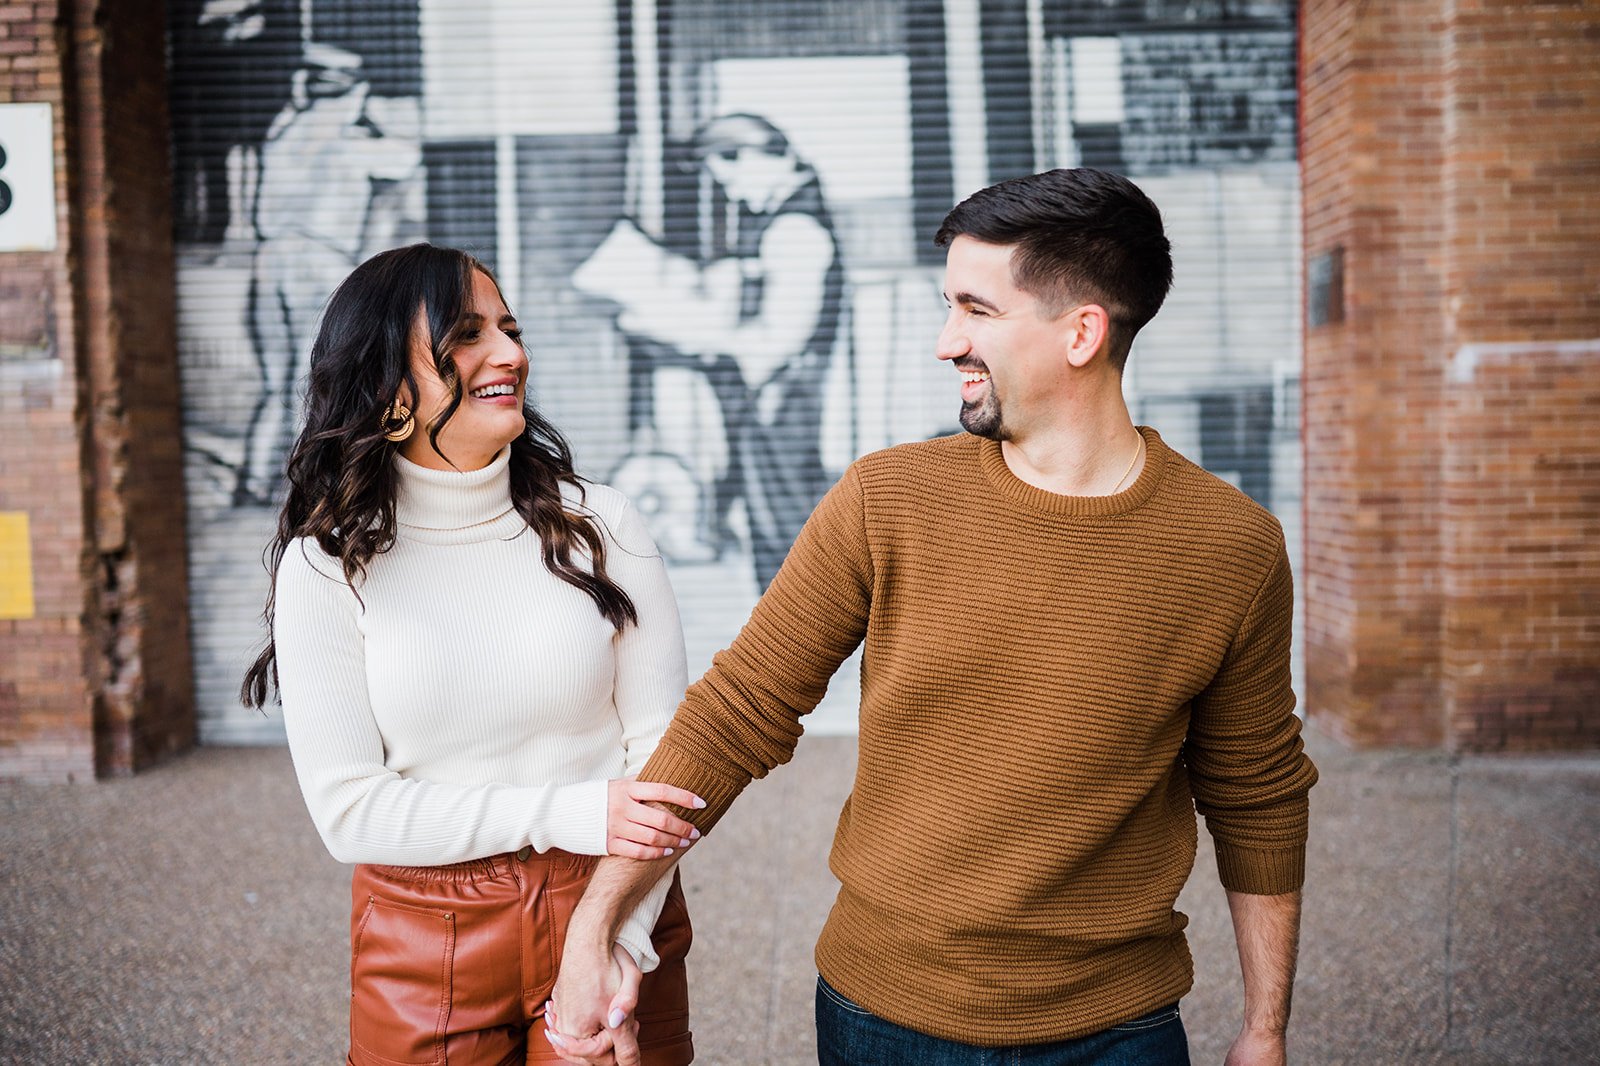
[235,43,422,503]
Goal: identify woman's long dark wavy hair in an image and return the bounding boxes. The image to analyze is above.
[240,245,638,707]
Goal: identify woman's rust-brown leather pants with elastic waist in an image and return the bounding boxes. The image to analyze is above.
[349,848,694,1066]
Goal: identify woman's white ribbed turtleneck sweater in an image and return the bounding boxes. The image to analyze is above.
[272,448,688,972]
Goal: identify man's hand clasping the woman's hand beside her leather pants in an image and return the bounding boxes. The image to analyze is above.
[544,940,643,1066]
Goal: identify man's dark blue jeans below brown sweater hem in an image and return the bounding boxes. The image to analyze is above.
[816,976,1189,1066]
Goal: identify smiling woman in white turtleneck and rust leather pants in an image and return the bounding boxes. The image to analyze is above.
[243,245,701,1066]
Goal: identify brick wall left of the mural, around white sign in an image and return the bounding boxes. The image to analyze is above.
[0,0,194,779]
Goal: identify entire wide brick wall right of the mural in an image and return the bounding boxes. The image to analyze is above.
[1301,0,1600,749]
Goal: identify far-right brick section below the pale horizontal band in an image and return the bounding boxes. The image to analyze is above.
[1442,341,1600,751]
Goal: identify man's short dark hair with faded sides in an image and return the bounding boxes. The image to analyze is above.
[933,166,1173,368]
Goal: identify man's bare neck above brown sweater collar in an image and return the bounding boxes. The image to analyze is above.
[1000,391,1144,496]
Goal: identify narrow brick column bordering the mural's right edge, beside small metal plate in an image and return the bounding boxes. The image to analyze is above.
[1301,0,1445,746]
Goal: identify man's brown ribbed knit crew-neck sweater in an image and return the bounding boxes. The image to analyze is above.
[640,429,1317,1045]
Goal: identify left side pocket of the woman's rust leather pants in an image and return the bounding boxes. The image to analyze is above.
[350,895,456,1066]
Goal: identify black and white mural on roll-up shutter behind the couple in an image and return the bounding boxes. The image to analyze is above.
[168,0,1299,743]
